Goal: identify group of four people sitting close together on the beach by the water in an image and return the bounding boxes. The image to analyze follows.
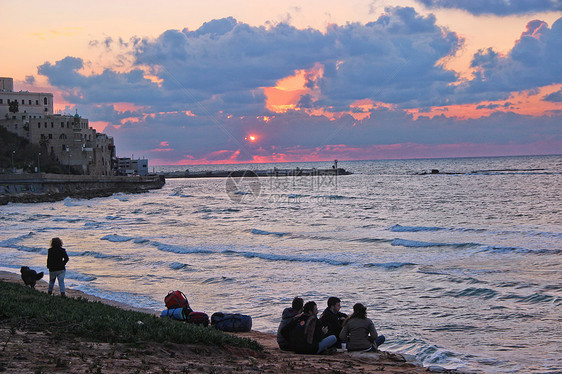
[277,297,385,354]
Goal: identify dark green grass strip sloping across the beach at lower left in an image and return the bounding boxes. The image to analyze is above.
[0,281,263,351]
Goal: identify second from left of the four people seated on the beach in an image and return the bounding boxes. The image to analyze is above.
[286,301,332,354]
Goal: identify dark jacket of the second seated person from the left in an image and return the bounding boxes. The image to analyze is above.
[287,314,323,354]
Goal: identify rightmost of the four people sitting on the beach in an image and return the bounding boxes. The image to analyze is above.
[340,303,385,352]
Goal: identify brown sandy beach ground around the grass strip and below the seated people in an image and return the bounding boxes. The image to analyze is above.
[0,272,460,373]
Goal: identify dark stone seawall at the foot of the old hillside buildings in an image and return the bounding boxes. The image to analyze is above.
[0,173,165,205]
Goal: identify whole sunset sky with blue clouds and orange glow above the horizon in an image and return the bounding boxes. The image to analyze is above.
[0,0,562,165]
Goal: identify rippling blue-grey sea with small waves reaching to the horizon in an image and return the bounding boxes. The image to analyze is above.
[0,155,562,373]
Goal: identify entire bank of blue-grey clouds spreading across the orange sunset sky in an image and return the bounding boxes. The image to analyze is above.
[38,7,562,160]
